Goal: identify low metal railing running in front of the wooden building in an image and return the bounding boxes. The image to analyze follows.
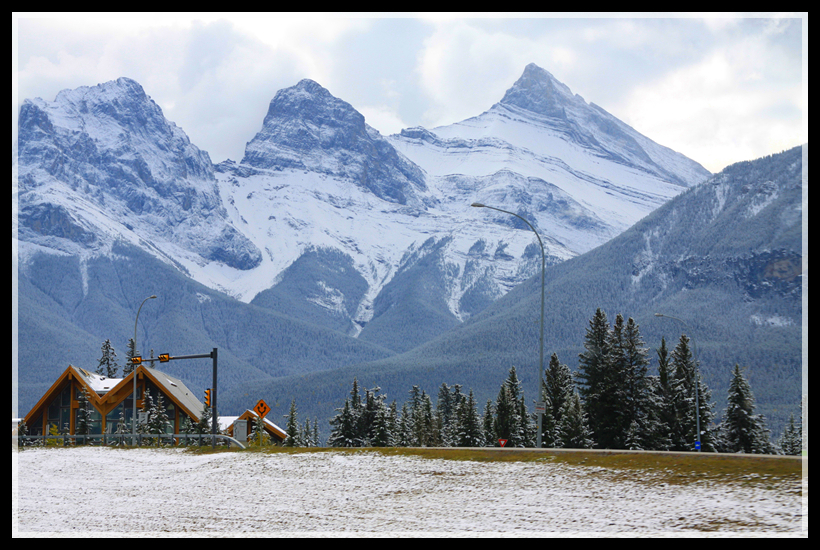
[11,434,246,449]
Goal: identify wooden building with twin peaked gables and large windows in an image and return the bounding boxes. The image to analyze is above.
[23,365,204,435]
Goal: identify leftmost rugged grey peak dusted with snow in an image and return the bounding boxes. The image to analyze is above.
[12,78,261,271]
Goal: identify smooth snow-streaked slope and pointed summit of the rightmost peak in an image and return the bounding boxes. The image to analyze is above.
[388,64,709,250]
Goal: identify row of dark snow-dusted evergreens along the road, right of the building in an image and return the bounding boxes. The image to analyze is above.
[302,309,802,455]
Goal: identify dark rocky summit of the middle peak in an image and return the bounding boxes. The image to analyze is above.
[242,79,425,206]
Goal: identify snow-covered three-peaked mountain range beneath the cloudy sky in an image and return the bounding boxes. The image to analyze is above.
[14,65,708,350]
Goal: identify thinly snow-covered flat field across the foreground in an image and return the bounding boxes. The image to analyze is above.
[12,447,808,538]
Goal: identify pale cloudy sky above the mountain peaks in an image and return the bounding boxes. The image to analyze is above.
[12,13,808,172]
